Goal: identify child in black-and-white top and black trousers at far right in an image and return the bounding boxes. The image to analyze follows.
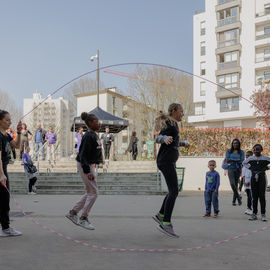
[243,144,270,221]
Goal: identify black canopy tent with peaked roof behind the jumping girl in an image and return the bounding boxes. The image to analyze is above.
[71,107,128,133]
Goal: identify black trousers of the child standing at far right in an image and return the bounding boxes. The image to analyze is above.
[251,174,266,215]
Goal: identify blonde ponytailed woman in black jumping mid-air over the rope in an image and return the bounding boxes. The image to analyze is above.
[153,103,189,238]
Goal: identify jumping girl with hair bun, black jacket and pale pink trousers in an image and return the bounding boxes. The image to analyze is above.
[66,112,102,230]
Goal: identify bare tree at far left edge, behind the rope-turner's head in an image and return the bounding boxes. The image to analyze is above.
[0,90,22,128]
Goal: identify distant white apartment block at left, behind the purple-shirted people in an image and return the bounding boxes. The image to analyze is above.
[23,93,75,158]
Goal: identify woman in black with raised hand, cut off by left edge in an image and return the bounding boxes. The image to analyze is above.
[0,110,22,237]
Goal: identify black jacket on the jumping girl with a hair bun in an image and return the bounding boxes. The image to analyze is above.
[76,130,102,174]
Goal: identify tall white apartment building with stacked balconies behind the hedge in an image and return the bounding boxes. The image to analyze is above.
[189,0,270,128]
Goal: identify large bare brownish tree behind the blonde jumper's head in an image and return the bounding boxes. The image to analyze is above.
[129,65,194,136]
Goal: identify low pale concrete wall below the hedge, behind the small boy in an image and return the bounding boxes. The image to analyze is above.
[161,157,270,191]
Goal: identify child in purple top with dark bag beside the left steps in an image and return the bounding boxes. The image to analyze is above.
[22,146,37,195]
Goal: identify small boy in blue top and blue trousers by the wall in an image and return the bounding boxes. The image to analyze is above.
[204,160,220,217]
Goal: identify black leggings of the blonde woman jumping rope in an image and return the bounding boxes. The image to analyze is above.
[158,163,179,222]
